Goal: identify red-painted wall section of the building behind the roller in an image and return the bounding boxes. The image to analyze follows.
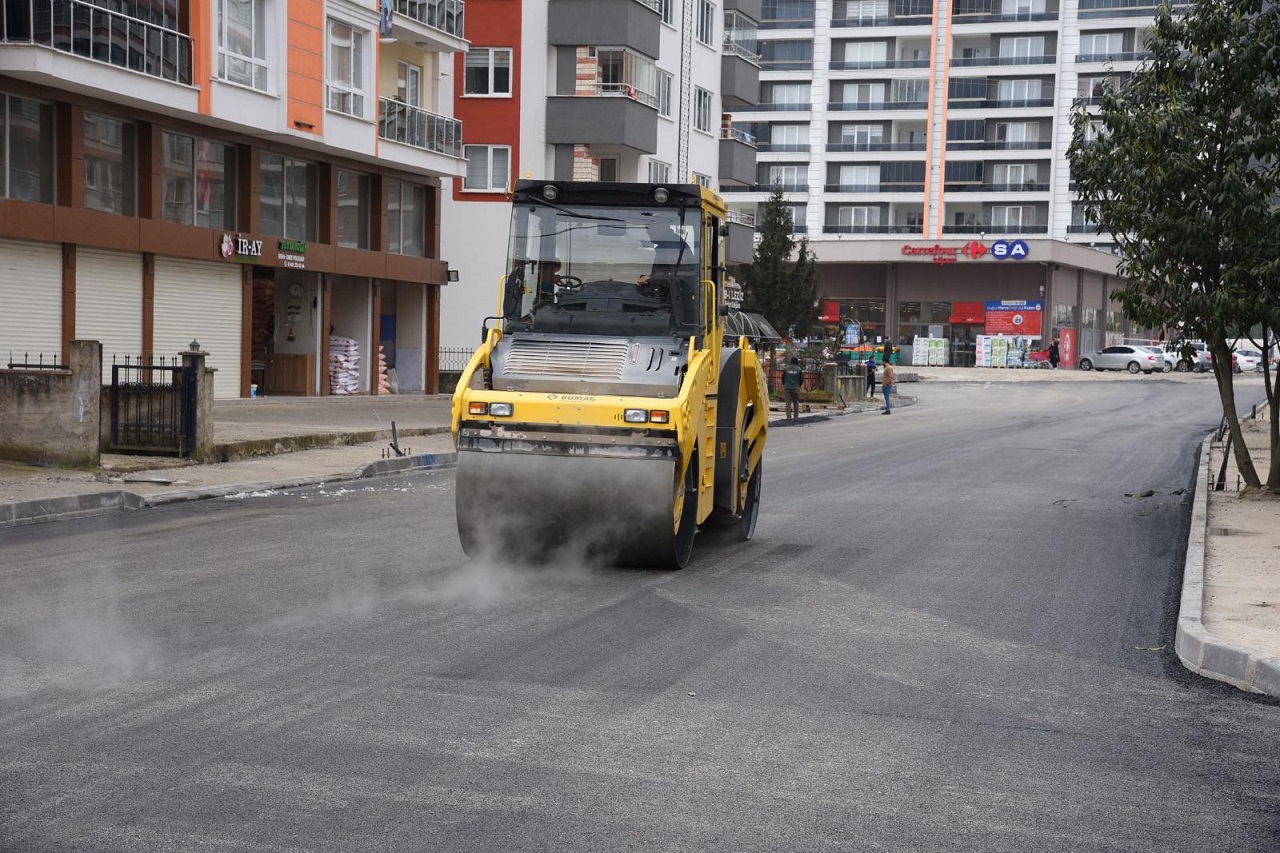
[453,0,524,201]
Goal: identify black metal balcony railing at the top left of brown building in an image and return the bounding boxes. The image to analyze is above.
[0,0,191,86]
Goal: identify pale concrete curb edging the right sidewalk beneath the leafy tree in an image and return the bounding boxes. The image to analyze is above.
[1174,435,1280,697]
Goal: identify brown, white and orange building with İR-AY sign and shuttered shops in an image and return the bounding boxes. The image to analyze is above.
[0,0,467,398]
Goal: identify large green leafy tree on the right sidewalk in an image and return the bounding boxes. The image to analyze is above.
[1069,0,1280,492]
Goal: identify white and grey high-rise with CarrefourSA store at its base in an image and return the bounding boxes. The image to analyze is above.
[724,0,1155,351]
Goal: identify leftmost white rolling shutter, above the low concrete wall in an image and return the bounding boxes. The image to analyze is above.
[0,240,63,368]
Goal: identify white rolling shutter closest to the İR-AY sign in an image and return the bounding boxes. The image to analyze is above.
[155,257,246,400]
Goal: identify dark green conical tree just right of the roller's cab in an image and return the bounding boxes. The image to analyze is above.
[735,188,818,336]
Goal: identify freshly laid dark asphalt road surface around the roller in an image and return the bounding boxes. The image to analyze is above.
[0,377,1280,853]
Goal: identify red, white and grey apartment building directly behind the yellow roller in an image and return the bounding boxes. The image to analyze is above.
[440,0,760,356]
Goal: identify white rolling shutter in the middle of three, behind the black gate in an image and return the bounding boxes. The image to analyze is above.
[76,247,142,366]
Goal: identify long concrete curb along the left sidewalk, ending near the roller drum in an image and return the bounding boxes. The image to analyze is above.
[0,452,458,522]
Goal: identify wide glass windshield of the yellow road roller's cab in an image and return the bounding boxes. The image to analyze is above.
[503,199,703,337]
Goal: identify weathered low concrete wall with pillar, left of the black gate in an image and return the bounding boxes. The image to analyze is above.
[0,341,102,467]
